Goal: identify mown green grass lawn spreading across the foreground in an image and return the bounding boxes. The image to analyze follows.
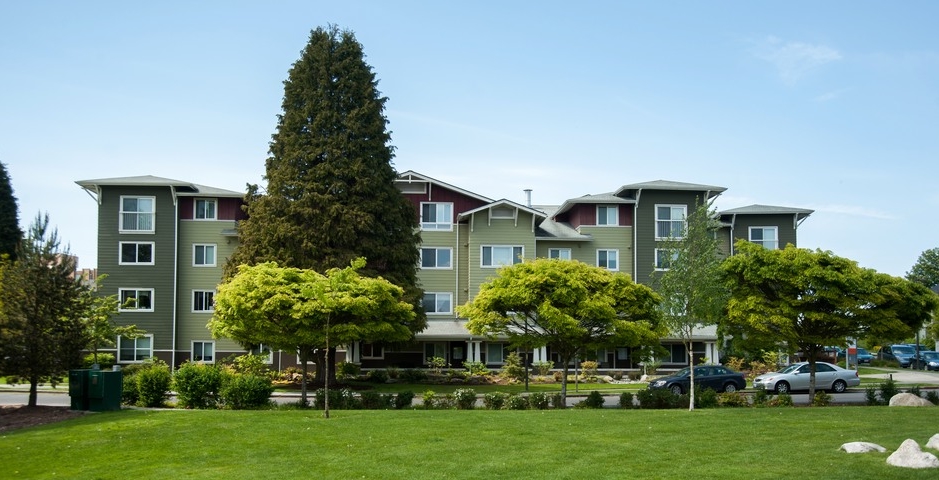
[0,407,939,480]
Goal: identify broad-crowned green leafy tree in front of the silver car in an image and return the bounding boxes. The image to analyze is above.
[722,240,937,398]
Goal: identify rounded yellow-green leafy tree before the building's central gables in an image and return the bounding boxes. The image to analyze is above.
[457,259,666,399]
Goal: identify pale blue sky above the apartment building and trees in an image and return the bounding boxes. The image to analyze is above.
[0,0,939,275]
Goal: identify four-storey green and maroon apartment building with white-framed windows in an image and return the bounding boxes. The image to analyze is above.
[77,171,812,370]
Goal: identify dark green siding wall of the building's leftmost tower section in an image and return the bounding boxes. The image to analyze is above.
[98,187,176,355]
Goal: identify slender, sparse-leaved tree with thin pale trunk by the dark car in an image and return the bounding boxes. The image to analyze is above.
[653,204,730,410]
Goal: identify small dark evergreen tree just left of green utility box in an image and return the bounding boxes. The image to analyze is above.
[0,215,88,406]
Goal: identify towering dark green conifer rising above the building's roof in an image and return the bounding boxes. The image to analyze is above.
[226,26,426,380]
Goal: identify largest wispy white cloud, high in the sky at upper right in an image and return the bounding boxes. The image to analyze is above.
[753,36,842,85]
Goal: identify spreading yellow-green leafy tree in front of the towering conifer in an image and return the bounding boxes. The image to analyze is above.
[208,259,414,412]
